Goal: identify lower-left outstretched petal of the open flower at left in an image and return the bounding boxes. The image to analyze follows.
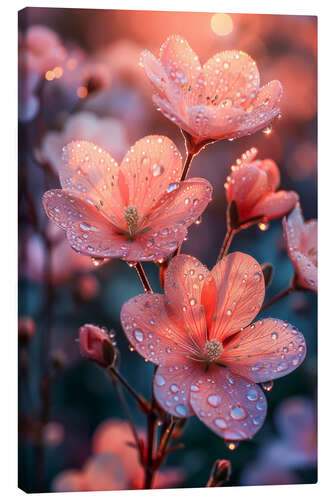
[43,189,128,258]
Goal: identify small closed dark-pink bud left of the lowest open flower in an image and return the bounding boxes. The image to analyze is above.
[79,324,118,366]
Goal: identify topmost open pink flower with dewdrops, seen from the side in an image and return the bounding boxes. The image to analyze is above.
[141,35,282,144]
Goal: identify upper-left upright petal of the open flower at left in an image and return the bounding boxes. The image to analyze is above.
[59,141,124,225]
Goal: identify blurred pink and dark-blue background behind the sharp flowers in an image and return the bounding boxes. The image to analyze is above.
[19,8,317,492]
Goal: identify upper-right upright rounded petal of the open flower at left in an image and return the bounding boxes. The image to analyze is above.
[120,135,182,217]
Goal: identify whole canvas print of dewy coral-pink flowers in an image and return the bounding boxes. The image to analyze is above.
[18,8,318,493]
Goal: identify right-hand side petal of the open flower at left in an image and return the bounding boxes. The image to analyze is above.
[148,178,212,228]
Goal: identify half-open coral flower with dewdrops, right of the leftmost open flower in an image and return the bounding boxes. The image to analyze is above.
[224,148,298,221]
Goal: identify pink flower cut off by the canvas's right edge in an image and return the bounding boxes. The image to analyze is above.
[282,203,318,292]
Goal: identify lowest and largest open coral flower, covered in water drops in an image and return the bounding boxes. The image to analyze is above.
[121,252,306,440]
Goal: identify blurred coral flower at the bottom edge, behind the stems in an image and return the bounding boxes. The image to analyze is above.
[52,419,184,492]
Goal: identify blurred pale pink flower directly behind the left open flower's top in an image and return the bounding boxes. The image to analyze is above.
[40,111,129,172]
